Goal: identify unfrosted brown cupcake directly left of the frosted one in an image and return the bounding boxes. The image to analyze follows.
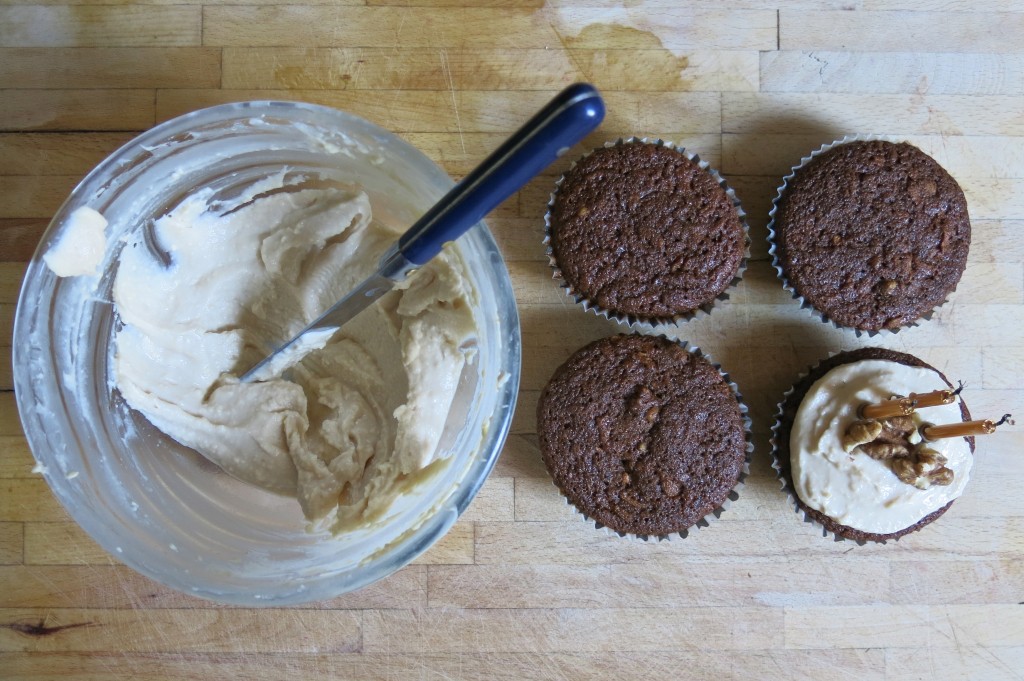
[537,335,751,539]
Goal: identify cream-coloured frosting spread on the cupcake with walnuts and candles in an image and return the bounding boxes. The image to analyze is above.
[790,359,973,535]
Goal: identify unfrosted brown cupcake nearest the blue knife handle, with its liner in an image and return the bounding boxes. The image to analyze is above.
[545,138,748,326]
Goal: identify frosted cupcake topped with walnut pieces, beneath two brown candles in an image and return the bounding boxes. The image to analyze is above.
[772,348,974,544]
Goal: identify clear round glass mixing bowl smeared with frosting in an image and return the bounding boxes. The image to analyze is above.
[13,101,520,605]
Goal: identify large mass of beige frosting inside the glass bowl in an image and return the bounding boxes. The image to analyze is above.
[101,175,476,531]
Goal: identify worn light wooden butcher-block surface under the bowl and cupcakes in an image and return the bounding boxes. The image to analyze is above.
[0,0,1024,681]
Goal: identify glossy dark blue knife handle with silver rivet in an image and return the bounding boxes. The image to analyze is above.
[398,83,604,265]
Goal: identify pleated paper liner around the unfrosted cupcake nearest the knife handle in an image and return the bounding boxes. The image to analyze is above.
[543,137,751,329]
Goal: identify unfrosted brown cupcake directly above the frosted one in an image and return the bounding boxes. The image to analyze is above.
[769,139,971,334]
